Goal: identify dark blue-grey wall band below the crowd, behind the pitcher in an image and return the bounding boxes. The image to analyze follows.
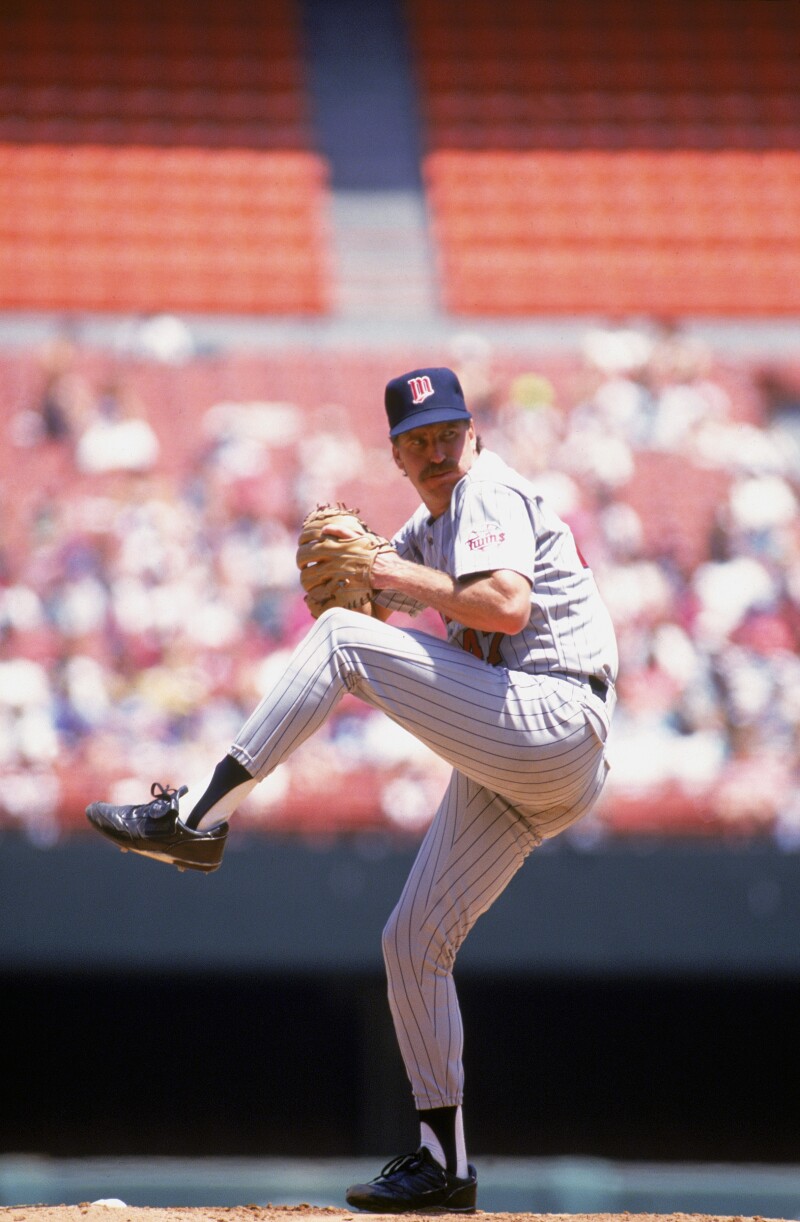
[0,835,800,978]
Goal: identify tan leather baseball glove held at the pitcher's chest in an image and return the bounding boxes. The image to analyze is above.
[297,501,393,620]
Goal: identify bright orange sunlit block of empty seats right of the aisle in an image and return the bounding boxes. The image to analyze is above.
[425,149,800,316]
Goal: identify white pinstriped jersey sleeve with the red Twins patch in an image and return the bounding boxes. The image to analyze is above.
[453,480,536,585]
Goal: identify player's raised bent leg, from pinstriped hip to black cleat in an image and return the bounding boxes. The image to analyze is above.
[87,609,602,873]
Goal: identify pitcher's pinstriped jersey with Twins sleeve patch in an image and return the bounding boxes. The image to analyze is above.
[379,450,618,683]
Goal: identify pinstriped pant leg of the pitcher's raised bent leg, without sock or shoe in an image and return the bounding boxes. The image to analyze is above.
[231,609,602,819]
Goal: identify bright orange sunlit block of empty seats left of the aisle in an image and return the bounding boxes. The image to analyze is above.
[0,144,329,314]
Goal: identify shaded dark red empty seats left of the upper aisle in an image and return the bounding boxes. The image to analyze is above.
[0,0,313,149]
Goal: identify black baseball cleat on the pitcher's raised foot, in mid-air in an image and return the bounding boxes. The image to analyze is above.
[87,781,228,874]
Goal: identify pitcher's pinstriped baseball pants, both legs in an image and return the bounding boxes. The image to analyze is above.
[231,609,607,1108]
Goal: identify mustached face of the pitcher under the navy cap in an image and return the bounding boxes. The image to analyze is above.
[392,420,476,518]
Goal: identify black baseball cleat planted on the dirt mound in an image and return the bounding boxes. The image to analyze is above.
[346,1146,478,1213]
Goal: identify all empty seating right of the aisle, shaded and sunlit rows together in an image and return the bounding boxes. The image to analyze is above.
[409,0,800,315]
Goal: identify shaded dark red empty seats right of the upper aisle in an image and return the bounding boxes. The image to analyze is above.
[408,0,800,149]
